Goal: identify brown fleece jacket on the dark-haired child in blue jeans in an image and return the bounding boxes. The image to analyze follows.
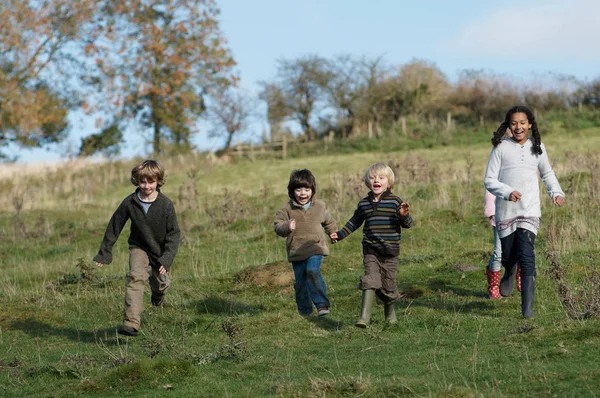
[273,199,337,262]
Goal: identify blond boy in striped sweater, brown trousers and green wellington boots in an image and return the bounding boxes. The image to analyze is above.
[330,163,413,328]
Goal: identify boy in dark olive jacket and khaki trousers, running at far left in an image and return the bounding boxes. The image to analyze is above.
[94,160,180,336]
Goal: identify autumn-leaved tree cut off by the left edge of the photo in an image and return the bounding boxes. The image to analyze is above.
[0,0,93,160]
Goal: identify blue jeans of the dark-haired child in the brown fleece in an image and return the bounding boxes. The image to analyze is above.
[292,256,329,315]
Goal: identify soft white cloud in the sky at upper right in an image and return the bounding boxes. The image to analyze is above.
[442,0,600,62]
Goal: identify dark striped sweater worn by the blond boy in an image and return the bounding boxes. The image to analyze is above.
[337,190,413,257]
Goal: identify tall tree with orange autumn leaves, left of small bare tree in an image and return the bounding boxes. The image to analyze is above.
[87,0,236,155]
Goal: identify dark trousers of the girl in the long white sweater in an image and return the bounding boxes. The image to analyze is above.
[500,228,536,277]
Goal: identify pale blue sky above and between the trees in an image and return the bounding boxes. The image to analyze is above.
[11,0,600,163]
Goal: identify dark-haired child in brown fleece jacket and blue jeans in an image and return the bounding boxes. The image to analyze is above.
[274,169,337,316]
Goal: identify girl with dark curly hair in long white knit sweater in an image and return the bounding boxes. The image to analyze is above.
[484,105,565,318]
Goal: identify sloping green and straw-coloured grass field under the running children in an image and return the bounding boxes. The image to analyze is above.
[0,129,600,397]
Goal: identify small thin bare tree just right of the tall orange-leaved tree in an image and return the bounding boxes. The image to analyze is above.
[208,89,253,153]
